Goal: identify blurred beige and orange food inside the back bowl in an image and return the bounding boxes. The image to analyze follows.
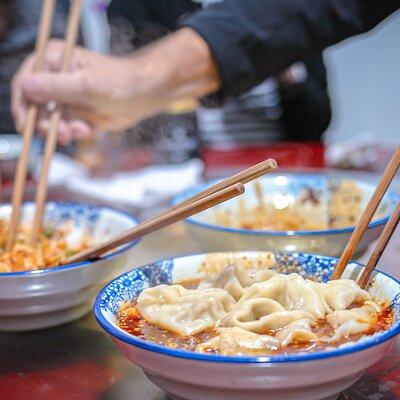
[210,179,363,231]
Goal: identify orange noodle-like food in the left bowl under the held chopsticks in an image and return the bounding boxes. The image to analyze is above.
[0,220,90,273]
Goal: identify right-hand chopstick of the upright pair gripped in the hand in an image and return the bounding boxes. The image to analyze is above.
[30,0,83,245]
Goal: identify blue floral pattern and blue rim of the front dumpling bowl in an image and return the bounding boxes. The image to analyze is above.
[93,253,400,363]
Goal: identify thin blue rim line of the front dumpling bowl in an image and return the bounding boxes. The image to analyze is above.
[93,251,400,364]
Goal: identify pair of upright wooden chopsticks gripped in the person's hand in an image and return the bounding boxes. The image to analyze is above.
[6,0,83,251]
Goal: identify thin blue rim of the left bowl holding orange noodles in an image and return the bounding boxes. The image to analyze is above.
[0,201,140,278]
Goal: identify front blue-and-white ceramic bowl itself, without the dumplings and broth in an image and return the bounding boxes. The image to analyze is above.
[94,252,400,400]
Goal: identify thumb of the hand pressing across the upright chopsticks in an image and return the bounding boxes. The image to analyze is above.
[21,71,88,106]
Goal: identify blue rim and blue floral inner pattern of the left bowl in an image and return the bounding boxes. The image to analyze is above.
[0,201,139,278]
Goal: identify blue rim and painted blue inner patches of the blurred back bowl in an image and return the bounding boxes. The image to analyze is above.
[172,173,399,236]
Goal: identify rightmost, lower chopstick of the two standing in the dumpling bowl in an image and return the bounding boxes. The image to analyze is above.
[357,202,400,289]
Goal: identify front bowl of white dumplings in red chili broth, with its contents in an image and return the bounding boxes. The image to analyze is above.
[94,251,400,400]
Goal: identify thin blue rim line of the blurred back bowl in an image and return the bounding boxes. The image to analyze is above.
[172,172,400,236]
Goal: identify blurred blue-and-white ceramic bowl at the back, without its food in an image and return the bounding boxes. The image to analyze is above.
[174,173,398,257]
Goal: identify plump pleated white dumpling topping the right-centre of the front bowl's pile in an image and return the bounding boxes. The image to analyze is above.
[239,274,332,318]
